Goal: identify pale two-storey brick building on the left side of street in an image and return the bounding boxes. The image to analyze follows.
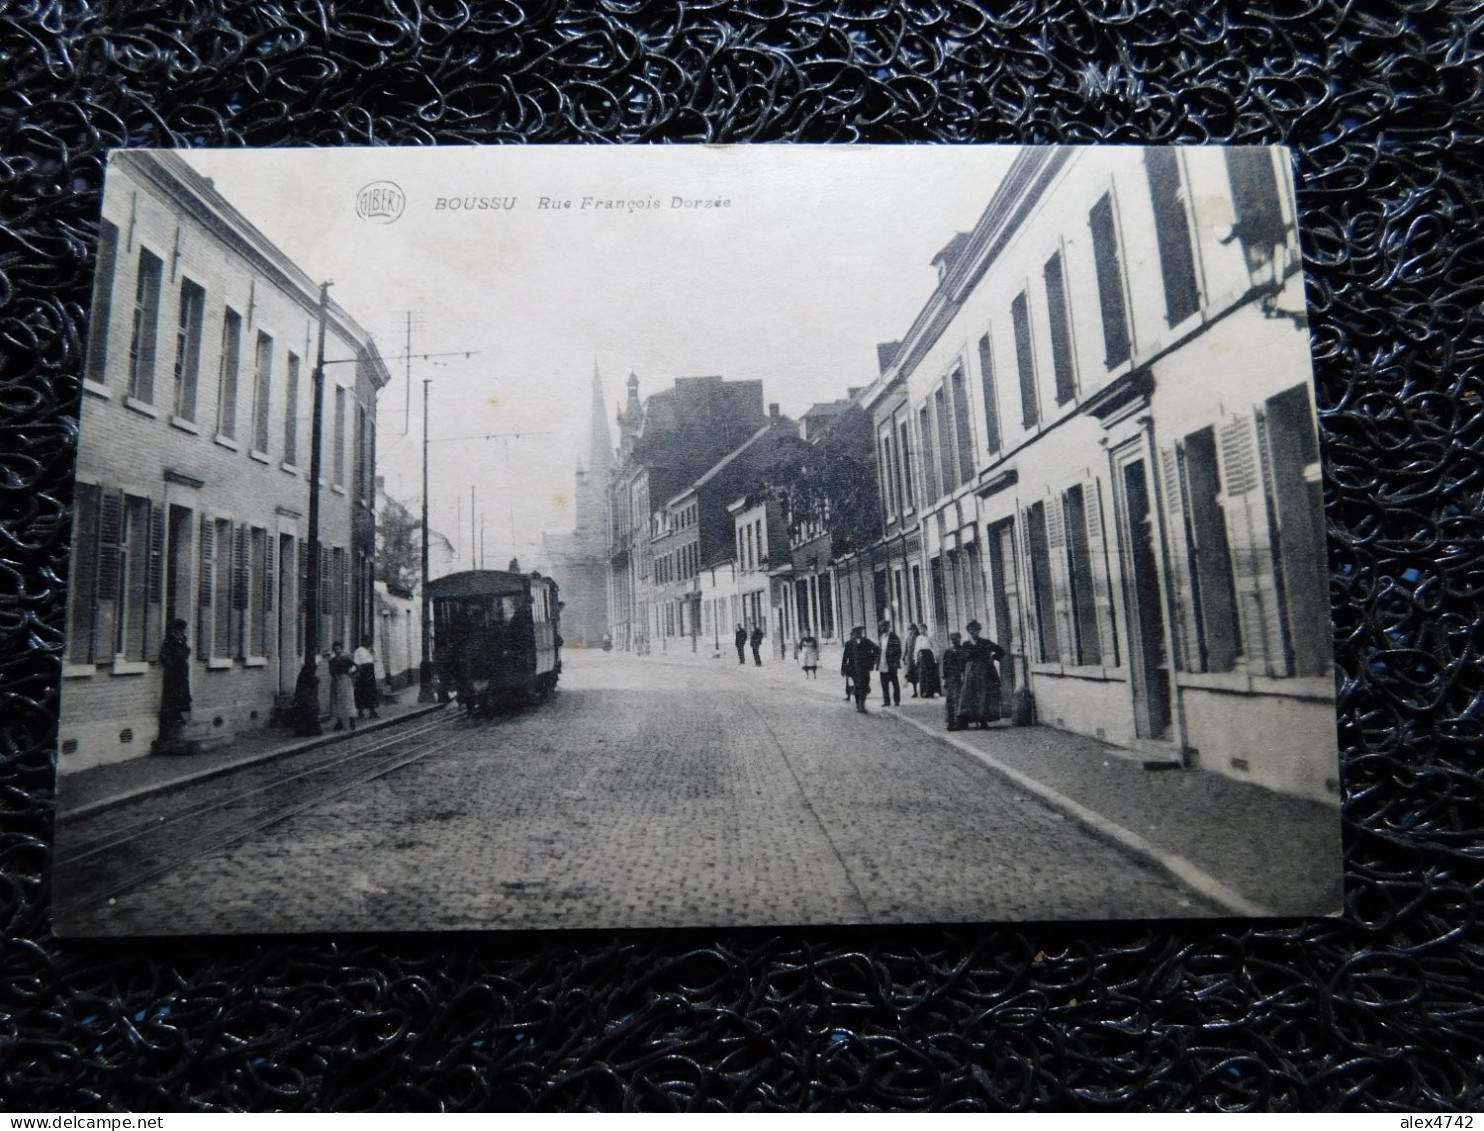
[61,151,387,772]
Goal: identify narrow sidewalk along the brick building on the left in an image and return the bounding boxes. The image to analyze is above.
[56,687,442,822]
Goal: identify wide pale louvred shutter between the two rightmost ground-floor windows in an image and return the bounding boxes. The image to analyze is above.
[1220,416,1287,675]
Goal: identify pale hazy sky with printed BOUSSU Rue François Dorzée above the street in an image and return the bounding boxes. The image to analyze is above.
[183,145,1014,567]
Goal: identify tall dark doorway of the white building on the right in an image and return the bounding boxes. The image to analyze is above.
[1117,451,1172,741]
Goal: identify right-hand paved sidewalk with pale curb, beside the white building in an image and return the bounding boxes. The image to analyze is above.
[641,646,1343,916]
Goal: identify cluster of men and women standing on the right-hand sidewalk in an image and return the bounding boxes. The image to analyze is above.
[836,620,1005,730]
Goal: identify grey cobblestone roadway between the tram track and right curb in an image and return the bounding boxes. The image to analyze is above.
[63,652,1258,934]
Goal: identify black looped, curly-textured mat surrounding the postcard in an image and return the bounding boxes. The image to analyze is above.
[0,0,1484,1110]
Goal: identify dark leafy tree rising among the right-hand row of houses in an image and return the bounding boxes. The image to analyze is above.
[763,404,881,558]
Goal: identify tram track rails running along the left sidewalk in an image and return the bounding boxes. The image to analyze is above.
[53,718,466,923]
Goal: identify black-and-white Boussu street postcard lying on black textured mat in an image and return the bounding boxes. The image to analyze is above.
[53,145,1342,937]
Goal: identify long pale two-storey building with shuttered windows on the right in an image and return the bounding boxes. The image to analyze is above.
[868,147,1339,800]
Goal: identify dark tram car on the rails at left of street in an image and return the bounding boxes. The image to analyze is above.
[427,570,561,714]
